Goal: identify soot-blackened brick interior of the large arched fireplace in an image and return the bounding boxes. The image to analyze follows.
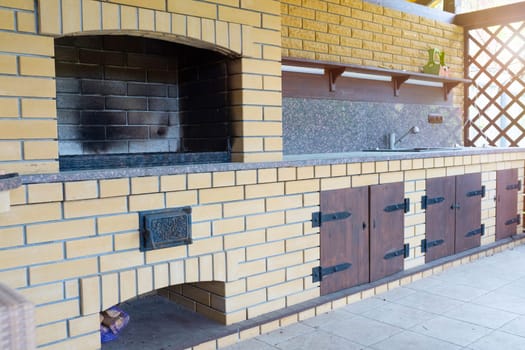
[55,36,230,169]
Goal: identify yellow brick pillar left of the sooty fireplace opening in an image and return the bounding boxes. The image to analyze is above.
[0,0,58,173]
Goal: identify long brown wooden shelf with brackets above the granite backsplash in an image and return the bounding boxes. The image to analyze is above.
[282,57,472,101]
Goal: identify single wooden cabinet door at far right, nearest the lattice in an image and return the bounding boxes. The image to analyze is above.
[496,169,521,240]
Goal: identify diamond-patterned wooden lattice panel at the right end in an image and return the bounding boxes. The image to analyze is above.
[465,21,525,147]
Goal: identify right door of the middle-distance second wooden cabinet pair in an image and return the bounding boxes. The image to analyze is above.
[455,173,482,253]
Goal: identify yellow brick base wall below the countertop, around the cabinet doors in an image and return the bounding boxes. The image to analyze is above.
[0,153,525,349]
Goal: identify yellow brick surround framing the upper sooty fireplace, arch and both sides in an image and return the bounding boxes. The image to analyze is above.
[0,0,282,173]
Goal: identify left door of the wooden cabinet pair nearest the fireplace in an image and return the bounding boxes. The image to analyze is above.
[321,187,369,295]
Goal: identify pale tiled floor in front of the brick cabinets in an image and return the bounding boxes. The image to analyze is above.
[226,246,525,350]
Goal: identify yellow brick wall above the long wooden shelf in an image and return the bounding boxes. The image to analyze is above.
[281,0,464,106]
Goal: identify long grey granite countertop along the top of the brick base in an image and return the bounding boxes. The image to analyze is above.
[20,147,525,185]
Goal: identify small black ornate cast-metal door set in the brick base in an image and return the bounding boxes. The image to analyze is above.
[139,207,192,251]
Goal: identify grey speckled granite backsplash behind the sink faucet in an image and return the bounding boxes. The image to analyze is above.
[283,98,463,155]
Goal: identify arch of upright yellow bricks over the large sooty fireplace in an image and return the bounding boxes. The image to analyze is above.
[38,0,242,57]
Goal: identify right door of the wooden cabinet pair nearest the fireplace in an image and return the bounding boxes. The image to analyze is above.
[370,183,404,282]
